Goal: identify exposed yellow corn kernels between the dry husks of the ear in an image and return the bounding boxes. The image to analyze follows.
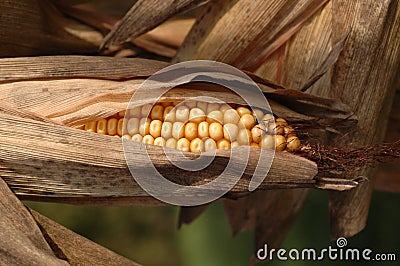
[84,101,301,152]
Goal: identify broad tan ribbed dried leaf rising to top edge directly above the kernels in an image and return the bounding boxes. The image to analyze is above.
[174,0,327,70]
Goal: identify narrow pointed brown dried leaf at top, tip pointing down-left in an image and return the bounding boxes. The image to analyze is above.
[101,0,207,47]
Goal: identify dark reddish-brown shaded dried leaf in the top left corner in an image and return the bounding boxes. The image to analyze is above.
[0,0,97,57]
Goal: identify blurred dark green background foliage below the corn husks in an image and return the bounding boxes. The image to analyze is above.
[26,190,400,266]
